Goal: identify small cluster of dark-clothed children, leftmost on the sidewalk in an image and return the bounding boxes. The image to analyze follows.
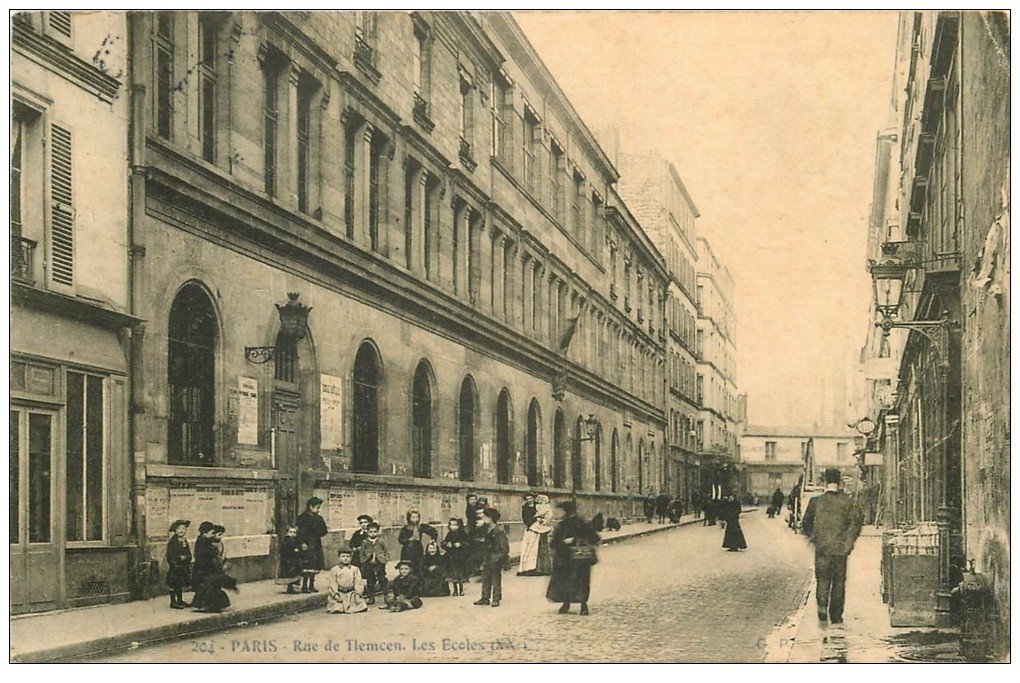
[166,519,238,612]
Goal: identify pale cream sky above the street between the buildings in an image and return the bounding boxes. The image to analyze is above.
[514,11,897,424]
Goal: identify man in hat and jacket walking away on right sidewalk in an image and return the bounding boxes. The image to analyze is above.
[801,467,861,624]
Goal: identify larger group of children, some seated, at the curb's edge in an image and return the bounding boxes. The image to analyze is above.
[310,508,510,614]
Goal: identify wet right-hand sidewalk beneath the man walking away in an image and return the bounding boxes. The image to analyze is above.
[765,527,962,664]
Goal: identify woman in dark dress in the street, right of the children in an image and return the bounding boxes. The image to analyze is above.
[546,502,599,615]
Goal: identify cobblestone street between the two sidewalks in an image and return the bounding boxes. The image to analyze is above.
[104,511,811,662]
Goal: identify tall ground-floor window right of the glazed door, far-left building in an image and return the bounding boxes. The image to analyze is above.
[65,372,105,541]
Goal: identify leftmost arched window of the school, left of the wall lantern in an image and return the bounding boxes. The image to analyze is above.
[166,283,218,465]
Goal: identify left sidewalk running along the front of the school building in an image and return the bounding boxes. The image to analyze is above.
[10,515,701,663]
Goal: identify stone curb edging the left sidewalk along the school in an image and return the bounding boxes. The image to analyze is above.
[10,519,718,664]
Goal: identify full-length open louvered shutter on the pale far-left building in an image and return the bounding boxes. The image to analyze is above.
[50,123,74,286]
